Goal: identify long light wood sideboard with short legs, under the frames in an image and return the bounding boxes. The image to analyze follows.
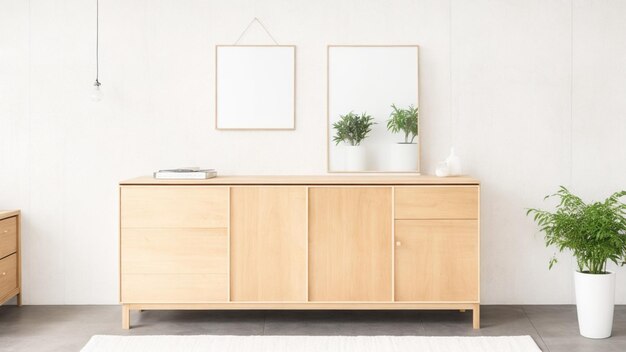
[120,176,480,329]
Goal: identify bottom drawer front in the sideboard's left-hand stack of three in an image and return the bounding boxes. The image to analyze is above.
[122,274,228,303]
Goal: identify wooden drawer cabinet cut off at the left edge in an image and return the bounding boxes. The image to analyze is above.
[0,210,22,306]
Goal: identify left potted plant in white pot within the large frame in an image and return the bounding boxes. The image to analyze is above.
[333,112,375,171]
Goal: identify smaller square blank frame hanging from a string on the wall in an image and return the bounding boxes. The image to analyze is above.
[215,45,296,130]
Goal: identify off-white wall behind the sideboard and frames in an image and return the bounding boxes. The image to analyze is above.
[0,0,626,304]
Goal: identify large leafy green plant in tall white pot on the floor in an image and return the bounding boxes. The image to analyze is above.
[526,186,626,339]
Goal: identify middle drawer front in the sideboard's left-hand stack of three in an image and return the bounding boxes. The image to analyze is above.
[121,229,228,274]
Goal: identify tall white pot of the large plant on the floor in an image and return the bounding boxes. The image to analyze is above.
[574,271,615,339]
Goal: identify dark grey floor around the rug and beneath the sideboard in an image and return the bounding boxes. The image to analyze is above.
[0,306,626,352]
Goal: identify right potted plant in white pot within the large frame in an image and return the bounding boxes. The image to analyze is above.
[387,104,419,171]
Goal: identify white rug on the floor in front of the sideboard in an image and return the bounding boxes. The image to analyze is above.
[82,335,541,352]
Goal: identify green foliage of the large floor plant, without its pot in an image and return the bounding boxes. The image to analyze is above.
[526,186,626,274]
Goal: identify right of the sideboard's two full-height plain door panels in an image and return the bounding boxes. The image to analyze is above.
[309,187,392,301]
